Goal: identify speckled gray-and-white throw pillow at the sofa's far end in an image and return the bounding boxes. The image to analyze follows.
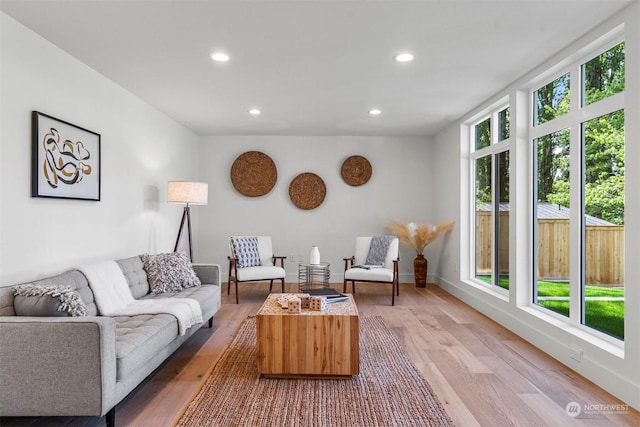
[142,252,201,294]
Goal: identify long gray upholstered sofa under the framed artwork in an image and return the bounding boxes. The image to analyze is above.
[0,257,221,425]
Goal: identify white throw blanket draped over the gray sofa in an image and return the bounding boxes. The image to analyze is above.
[78,261,202,335]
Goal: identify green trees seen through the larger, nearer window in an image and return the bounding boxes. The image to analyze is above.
[535,43,625,224]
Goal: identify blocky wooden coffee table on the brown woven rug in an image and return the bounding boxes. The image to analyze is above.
[256,294,360,378]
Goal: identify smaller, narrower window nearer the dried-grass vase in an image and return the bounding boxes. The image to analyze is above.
[472,107,510,289]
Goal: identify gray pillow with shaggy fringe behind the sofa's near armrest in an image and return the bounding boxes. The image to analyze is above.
[13,285,87,317]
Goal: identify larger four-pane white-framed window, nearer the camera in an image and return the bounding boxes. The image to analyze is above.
[530,43,625,339]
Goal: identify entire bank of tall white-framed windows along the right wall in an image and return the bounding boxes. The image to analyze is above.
[461,39,625,343]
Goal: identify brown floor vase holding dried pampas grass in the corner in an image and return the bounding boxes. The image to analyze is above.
[389,221,453,288]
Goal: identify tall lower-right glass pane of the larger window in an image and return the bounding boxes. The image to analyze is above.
[581,110,624,339]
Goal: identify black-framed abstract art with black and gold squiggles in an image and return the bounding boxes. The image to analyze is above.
[31,111,102,201]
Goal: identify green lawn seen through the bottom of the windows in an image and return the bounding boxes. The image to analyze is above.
[477,275,624,340]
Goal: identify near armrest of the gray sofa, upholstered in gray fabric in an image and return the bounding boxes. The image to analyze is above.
[0,316,117,416]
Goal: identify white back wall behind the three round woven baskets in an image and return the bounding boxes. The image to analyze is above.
[198,136,434,282]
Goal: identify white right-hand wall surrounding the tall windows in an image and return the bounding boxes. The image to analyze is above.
[433,2,640,409]
